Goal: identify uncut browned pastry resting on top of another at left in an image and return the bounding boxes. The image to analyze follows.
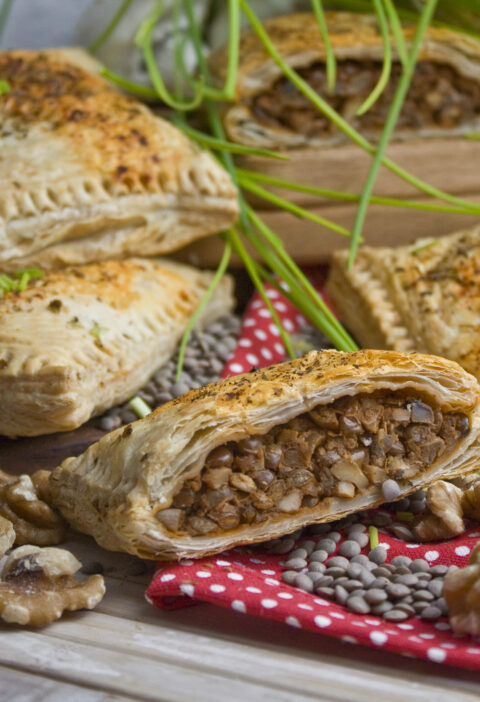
[0,49,238,270]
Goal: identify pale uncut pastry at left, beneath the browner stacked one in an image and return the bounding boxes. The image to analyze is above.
[0,259,233,436]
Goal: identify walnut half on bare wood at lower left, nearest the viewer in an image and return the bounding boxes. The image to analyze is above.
[0,545,105,626]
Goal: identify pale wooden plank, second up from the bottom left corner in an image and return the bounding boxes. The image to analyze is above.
[0,632,316,702]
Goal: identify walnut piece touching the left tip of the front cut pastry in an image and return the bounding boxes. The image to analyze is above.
[0,470,65,546]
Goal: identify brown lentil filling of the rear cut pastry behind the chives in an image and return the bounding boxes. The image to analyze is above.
[250,60,480,137]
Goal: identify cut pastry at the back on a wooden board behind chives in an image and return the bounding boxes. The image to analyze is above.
[211,12,480,148]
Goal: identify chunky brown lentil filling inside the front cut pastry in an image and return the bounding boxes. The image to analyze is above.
[156,391,469,536]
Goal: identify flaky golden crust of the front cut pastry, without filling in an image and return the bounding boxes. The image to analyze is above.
[50,351,480,559]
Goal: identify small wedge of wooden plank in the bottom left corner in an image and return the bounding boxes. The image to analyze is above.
[0,666,133,702]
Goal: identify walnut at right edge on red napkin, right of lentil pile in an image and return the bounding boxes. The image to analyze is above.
[443,542,480,636]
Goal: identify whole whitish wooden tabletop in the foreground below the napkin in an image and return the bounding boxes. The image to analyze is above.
[0,534,480,702]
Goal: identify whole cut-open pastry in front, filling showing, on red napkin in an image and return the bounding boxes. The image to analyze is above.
[50,351,480,559]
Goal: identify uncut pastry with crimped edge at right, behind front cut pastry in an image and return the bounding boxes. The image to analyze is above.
[328,227,480,378]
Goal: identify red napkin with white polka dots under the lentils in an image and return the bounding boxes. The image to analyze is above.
[146,269,480,669]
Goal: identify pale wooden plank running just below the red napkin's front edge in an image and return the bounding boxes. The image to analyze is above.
[36,608,478,702]
